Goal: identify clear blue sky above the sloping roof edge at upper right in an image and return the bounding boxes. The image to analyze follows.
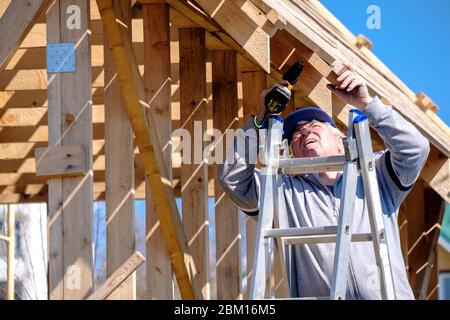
[321,0,450,126]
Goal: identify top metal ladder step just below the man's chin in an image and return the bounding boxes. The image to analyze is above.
[271,155,345,174]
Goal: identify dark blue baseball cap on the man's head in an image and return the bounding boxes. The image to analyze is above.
[283,107,336,143]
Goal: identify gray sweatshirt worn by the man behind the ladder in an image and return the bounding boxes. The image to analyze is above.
[217,97,429,299]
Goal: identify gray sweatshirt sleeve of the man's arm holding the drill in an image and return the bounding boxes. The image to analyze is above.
[216,121,261,215]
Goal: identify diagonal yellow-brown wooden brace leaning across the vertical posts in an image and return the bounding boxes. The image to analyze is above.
[97,0,201,299]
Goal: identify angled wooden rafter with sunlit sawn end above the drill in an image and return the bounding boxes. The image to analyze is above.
[196,0,270,72]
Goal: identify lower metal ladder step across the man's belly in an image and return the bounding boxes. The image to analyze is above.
[264,226,372,245]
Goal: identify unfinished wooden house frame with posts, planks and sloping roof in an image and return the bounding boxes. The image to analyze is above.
[0,0,450,299]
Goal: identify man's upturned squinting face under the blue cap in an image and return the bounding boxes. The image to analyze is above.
[291,120,342,157]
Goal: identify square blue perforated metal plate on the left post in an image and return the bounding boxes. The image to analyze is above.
[47,43,76,73]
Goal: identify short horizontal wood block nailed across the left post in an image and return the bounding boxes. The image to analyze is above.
[34,145,89,178]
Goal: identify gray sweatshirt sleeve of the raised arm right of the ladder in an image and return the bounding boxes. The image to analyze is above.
[364,97,430,208]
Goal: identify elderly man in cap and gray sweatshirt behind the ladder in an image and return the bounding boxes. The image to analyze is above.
[218,65,429,299]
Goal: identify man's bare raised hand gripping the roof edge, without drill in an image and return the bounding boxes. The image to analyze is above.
[327,63,372,109]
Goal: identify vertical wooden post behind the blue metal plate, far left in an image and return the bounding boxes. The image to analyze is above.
[47,0,92,299]
